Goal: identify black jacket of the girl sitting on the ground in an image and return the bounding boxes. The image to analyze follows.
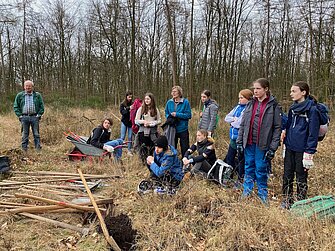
[184,139,216,166]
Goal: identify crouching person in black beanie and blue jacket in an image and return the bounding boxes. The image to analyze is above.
[147,136,184,193]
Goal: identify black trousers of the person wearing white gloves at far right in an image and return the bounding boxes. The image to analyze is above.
[283,148,308,203]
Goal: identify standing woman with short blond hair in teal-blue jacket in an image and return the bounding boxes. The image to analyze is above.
[165,86,192,156]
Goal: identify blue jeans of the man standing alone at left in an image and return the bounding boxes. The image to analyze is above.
[20,116,41,151]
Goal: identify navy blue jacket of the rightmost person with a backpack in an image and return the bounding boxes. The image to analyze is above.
[284,97,320,154]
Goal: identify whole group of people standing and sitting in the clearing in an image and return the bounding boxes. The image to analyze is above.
[14,78,326,208]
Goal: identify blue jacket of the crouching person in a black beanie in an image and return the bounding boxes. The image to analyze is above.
[150,145,184,181]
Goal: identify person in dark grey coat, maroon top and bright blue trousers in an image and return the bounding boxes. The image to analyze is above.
[236,78,281,204]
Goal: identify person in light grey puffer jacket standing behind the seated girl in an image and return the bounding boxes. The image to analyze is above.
[198,90,219,137]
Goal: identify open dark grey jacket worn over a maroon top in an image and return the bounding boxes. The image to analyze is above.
[236,95,281,151]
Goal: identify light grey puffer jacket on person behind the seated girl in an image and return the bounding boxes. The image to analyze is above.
[198,99,219,132]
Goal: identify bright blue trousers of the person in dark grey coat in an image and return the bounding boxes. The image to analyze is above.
[242,144,268,203]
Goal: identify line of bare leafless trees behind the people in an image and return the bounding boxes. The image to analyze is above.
[0,0,335,110]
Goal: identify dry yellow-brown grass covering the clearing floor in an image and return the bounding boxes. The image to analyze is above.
[0,109,335,250]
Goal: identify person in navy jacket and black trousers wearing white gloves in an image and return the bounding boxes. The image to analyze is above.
[281,81,320,209]
